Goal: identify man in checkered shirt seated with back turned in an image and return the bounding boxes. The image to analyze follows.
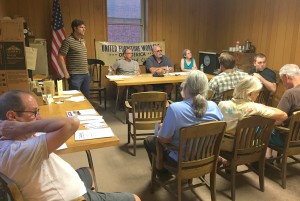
[208,53,248,103]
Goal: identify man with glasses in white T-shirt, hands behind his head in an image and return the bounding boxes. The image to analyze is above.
[0,90,140,201]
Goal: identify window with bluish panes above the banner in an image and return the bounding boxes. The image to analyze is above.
[107,0,144,43]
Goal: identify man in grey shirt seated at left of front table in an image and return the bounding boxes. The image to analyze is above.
[112,48,144,111]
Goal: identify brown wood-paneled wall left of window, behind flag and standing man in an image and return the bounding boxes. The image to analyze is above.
[0,0,107,74]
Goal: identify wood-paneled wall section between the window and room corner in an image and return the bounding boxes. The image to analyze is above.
[148,0,217,65]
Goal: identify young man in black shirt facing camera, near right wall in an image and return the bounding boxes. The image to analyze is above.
[253,53,276,93]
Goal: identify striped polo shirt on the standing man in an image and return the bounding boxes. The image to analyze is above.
[59,34,88,74]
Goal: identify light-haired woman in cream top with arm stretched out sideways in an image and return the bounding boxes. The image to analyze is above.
[218,75,287,157]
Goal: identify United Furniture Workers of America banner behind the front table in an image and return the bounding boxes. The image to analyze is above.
[95,41,165,66]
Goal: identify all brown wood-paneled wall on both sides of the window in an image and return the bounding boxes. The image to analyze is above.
[0,0,300,102]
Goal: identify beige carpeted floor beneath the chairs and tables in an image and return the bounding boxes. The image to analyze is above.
[61,103,300,201]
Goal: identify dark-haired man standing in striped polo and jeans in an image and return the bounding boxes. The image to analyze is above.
[58,19,90,98]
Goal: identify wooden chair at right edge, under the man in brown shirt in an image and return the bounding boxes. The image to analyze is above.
[266,111,300,189]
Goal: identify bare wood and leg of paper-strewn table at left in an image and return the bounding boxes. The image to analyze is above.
[39,94,120,188]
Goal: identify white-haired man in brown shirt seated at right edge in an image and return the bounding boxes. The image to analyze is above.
[267,64,300,151]
